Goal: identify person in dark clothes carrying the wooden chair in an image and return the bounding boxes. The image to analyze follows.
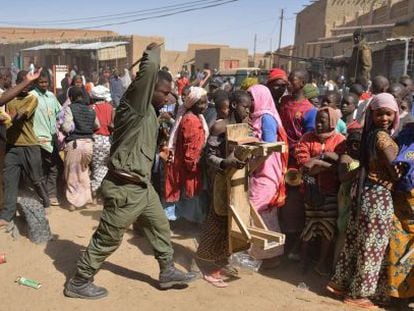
[196,91,251,288]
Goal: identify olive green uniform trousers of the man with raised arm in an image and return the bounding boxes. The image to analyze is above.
[77,178,173,279]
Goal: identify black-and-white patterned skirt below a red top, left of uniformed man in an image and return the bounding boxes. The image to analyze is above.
[91,134,111,192]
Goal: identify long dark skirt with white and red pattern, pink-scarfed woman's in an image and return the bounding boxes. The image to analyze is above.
[331,182,394,298]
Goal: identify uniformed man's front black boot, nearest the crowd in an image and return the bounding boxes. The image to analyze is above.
[159,260,197,289]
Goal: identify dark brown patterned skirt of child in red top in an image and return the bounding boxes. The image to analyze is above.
[301,195,338,242]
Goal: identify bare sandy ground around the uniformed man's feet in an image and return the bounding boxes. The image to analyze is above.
[0,206,364,311]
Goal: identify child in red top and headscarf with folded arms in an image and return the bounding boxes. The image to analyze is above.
[296,107,345,275]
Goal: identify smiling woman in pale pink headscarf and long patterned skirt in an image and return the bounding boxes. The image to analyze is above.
[327,93,399,309]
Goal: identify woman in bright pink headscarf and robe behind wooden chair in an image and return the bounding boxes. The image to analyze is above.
[248,85,288,269]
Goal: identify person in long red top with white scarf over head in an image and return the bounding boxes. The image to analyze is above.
[165,87,209,223]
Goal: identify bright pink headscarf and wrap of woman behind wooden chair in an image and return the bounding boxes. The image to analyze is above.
[248,85,289,211]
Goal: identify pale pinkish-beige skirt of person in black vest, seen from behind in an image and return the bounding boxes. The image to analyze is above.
[65,139,93,207]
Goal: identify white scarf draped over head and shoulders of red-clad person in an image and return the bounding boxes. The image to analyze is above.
[168,86,209,155]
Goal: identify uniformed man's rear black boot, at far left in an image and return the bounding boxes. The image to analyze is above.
[63,276,108,299]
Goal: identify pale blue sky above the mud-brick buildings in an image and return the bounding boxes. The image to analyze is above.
[0,0,310,53]
